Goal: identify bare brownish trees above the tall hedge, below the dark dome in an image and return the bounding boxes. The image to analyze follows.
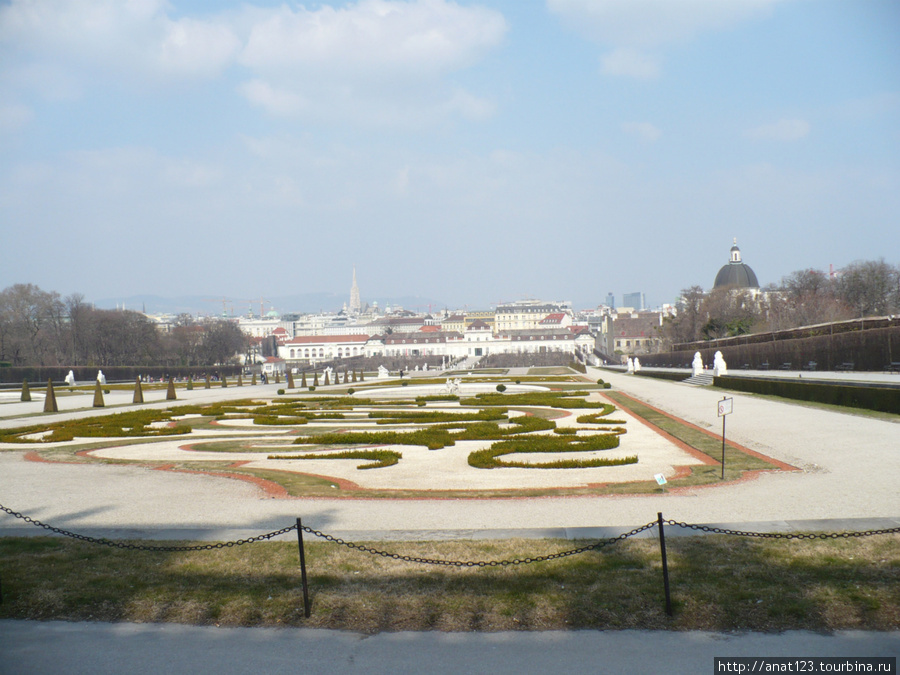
[660,258,900,345]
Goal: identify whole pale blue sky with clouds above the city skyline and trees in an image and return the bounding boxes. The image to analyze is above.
[0,0,900,311]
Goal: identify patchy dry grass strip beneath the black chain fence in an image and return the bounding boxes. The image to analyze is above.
[0,535,900,633]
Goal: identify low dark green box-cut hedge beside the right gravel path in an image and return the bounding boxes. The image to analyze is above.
[713,375,900,414]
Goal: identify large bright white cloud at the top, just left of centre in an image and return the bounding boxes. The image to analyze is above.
[239,0,507,127]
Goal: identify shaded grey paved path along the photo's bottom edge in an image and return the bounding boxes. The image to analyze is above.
[0,621,900,675]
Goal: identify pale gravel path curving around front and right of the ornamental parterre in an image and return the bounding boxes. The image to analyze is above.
[0,371,900,533]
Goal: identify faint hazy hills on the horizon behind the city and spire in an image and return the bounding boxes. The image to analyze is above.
[93,293,446,316]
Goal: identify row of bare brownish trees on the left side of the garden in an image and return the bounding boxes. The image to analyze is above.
[0,284,248,367]
